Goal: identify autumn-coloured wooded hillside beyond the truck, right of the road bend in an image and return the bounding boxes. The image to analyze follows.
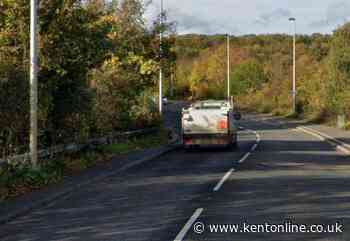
[176,23,350,126]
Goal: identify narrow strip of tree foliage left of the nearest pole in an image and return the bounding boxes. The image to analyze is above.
[0,0,29,146]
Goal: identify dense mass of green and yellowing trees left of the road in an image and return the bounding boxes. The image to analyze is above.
[0,0,175,155]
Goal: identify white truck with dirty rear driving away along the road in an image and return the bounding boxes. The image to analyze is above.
[182,100,240,147]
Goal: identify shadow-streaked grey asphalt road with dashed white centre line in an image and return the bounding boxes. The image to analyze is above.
[0,104,350,241]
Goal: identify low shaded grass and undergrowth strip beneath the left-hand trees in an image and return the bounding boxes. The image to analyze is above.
[0,129,169,201]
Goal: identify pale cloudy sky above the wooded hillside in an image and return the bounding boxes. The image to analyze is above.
[146,0,350,35]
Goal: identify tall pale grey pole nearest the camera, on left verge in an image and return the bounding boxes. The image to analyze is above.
[29,0,38,169]
